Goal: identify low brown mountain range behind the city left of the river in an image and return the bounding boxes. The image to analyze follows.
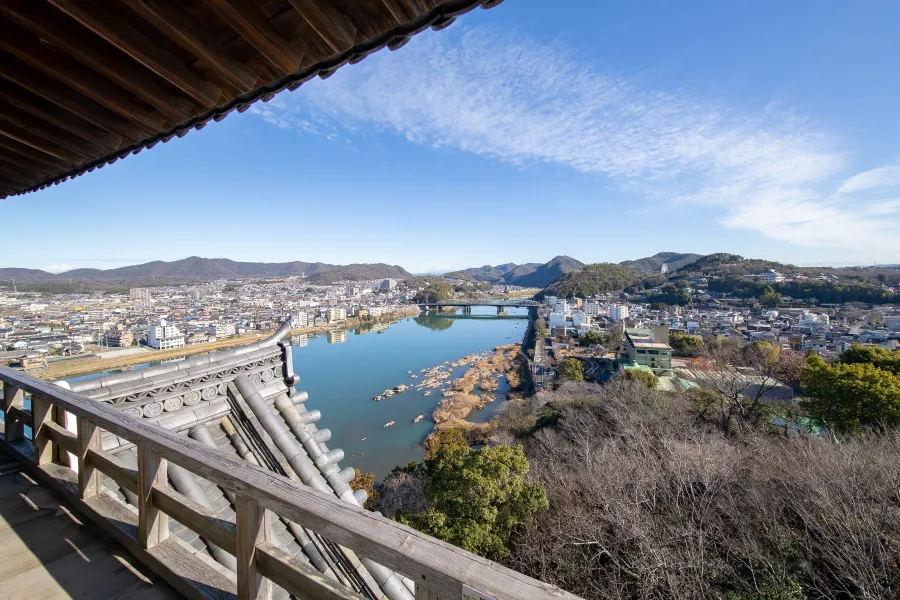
[0,256,411,284]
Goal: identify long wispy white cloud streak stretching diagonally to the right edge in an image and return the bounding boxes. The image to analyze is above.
[254,27,900,252]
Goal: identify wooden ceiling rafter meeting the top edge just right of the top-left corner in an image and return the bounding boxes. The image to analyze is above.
[47,0,222,108]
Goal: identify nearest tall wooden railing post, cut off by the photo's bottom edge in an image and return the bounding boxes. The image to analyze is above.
[235,494,271,600]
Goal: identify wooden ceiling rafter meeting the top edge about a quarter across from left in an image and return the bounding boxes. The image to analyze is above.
[206,0,303,75]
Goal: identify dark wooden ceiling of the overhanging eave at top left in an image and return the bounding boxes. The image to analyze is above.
[0,0,502,199]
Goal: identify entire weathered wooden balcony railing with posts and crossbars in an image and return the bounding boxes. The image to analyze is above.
[0,367,576,600]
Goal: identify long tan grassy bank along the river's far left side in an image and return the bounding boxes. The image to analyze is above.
[38,305,419,381]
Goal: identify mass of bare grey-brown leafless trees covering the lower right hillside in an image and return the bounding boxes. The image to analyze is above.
[497,381,900,600]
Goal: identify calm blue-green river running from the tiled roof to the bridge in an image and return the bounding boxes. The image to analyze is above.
[72,307,528,480]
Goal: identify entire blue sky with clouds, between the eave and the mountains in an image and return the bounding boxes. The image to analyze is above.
[0,0,900,272]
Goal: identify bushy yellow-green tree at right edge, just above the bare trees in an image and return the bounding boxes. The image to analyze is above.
[802,354,900,433]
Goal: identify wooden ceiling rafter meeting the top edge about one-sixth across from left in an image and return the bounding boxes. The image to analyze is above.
[123,0,259,93]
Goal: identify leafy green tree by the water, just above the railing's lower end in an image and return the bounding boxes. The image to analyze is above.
[398,446,549,559]
